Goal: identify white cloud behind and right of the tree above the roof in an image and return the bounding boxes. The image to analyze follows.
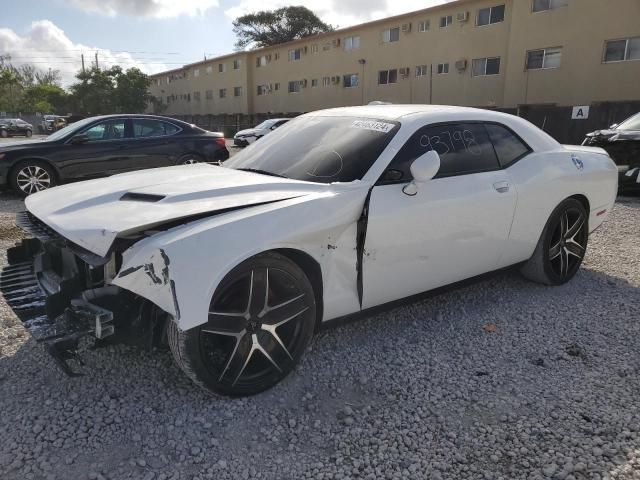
[225,0,451,28]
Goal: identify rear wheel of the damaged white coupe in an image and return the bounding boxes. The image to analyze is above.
[521,198,589,286]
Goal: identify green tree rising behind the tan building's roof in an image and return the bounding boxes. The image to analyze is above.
[233,7,333,50]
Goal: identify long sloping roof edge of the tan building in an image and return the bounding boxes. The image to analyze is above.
[149,0,470,78]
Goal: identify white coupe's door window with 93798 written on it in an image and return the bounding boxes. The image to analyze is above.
[381,123,500,183]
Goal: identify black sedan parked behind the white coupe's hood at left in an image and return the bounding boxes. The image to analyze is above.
[0,115,229,195]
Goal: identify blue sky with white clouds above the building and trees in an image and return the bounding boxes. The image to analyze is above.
[0,0,447,86]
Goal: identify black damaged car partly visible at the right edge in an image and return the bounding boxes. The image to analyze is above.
[582,113,640,192]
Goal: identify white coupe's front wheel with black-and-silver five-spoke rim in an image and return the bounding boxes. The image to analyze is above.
[167,252,316,396]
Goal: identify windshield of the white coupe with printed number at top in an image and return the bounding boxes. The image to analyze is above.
[224,116,400,183]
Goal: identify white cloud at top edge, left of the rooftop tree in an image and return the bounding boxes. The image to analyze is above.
[66,0,218,18]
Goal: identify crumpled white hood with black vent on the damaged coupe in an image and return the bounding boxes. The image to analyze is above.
[25,164,328,256]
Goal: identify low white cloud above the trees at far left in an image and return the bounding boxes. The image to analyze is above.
[0,20,167,86]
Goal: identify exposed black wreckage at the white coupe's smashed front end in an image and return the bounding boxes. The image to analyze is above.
[0,212,168,376]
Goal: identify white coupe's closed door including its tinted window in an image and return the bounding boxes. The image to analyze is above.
[363,123,516,308]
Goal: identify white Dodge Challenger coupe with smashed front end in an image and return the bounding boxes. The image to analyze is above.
[0,105,618,396]
